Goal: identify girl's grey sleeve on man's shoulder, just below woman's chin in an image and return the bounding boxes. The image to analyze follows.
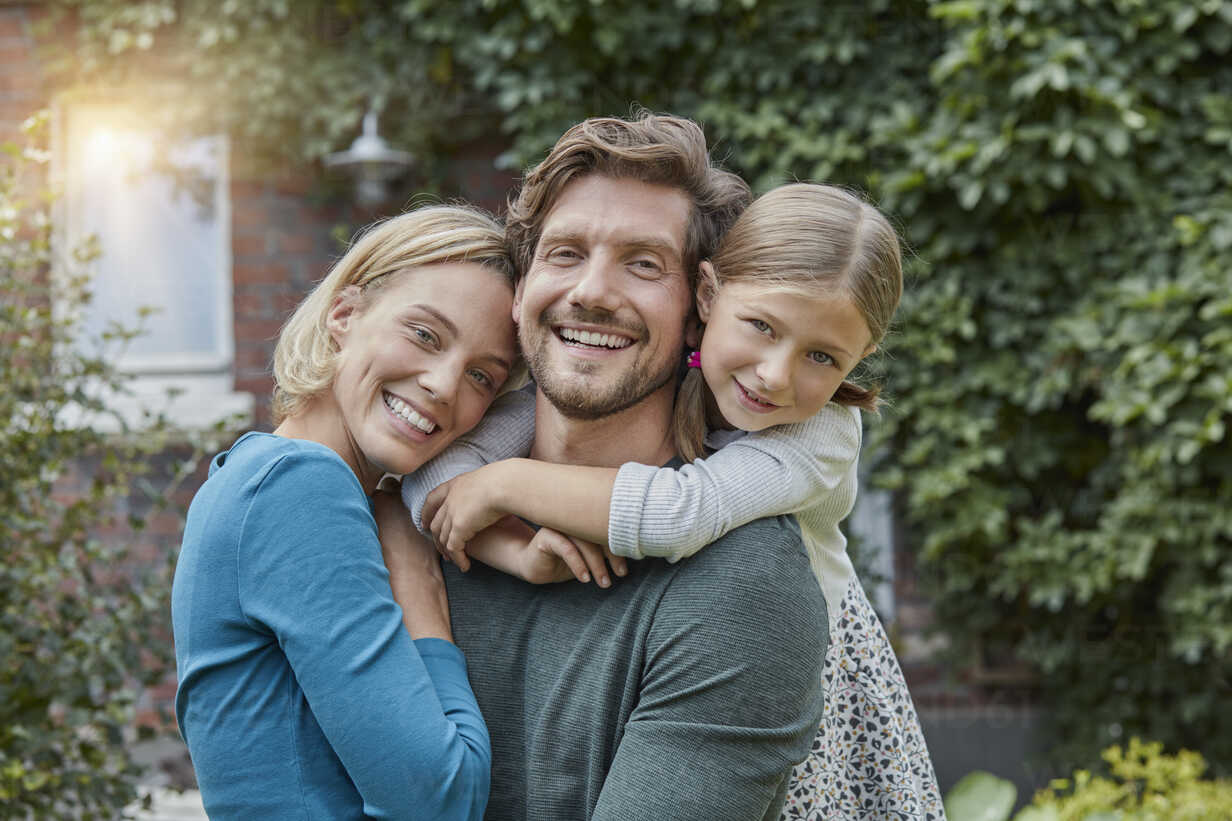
[402,385,535,535]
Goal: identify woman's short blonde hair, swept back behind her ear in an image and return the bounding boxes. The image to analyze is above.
[272,206,514,424]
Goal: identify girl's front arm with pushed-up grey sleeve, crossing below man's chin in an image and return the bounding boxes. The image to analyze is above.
[424,404,861,561]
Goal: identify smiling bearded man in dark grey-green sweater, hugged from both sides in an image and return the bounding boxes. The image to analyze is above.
[423,116,828,821]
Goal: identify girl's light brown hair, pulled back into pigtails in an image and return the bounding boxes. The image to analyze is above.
[674,182,903,461]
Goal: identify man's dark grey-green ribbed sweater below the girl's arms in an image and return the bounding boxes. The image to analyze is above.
[446,507,829,821]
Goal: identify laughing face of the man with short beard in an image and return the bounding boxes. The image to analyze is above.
[514,174,692,419]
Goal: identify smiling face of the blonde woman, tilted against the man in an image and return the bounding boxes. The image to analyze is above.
[326,263,516,487]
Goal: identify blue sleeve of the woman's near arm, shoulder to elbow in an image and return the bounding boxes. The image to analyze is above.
[237,451,492,820]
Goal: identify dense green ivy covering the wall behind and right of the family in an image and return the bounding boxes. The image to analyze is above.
[50,0,1232,770]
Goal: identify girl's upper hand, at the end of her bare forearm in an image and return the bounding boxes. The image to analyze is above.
[421,462,510,572]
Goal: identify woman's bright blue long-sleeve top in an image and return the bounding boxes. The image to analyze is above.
[171,433,492,821]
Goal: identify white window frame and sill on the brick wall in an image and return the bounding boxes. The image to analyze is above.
[52,95,255,429]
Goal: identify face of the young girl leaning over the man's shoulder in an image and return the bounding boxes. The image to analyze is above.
[697,276,875,430]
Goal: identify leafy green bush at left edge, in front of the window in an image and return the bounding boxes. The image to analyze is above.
[0,117,209,819]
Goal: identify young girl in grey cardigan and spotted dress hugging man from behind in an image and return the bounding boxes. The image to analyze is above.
[404,184,942,819]
